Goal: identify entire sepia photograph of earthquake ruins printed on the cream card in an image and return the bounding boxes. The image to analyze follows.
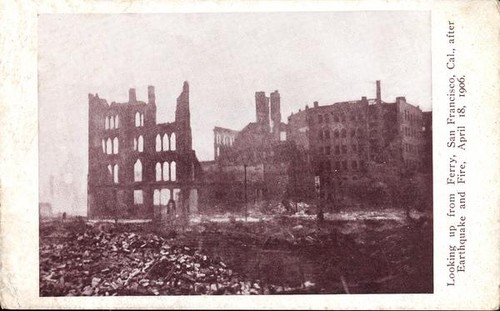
[37,10,435,297]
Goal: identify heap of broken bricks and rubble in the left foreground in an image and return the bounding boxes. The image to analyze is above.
[40,227,272,296]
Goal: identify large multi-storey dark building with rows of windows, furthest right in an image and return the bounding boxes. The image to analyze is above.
[288,81,430,207]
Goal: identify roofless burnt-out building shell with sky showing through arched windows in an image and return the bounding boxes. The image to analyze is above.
[87,82,201,219]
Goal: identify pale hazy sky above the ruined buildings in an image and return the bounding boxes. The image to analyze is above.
[38,11,431,217]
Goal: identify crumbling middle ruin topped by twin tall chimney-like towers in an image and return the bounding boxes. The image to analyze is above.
[202,91,288,208]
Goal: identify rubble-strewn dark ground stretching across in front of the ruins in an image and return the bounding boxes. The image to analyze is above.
[40,210,433,296]
